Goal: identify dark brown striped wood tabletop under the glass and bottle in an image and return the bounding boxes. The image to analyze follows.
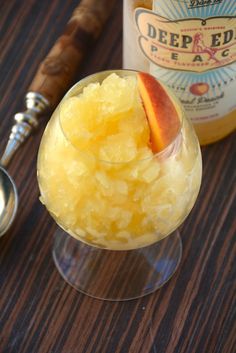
[0,0,236,353]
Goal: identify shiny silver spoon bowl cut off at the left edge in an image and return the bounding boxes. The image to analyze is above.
[0,166,18,237]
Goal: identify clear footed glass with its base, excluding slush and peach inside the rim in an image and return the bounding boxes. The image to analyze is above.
[37,70,202,300]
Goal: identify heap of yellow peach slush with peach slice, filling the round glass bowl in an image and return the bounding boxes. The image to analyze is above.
[38,71,201,250]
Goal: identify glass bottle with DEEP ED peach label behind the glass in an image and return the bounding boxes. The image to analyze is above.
[123,0,236,145]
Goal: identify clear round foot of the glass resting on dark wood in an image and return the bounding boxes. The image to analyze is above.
[53,228,182,301]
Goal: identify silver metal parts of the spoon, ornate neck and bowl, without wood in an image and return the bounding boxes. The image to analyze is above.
[0,92,49,237]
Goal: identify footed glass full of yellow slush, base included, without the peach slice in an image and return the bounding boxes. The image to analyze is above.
[37,70,202,300]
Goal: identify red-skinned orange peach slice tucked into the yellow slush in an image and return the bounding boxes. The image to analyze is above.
[137,72,180,153]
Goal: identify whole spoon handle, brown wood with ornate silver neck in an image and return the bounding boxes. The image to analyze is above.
[0,0,115,167]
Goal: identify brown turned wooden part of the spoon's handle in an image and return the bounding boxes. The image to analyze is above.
[29,0,115,108]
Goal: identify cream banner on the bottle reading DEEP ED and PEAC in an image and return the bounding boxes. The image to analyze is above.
[135,8,236,72]
